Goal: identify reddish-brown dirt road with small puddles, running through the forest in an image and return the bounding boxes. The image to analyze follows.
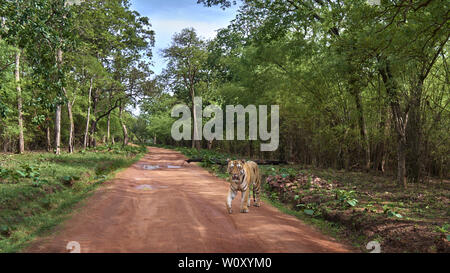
[24,148,352,253]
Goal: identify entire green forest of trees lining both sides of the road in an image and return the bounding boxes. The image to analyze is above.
[0,0,450,252]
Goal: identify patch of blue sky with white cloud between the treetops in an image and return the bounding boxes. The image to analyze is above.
[131,0,237,74]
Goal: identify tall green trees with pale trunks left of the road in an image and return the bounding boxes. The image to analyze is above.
[0,0,154,154]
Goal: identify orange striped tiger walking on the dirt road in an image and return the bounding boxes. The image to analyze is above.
[226,159,261,214]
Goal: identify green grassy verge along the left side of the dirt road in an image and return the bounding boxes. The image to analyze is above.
[0,145,146,253]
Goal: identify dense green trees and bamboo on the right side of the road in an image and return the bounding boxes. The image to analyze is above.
[136,0,450,187]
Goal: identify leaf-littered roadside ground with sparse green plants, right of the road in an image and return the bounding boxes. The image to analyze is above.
[166,146,450,253]
